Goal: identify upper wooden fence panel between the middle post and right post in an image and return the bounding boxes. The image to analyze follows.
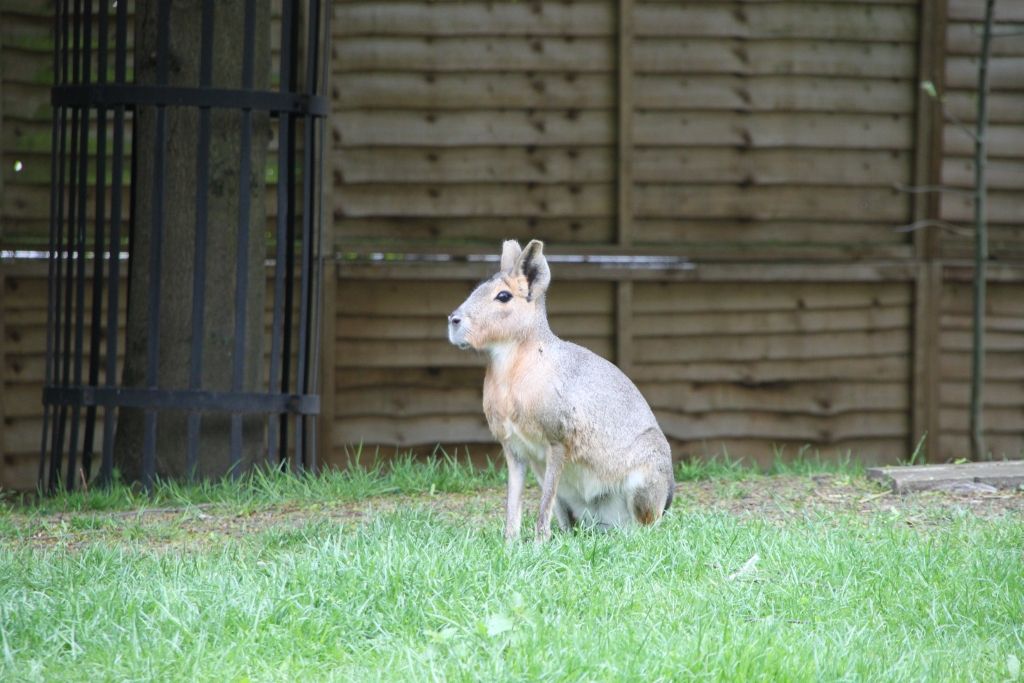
[633,0,919,258]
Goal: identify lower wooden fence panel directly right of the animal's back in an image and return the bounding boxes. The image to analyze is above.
[632,282,911,462]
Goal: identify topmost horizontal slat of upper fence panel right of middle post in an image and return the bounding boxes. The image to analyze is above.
[633,2,918,42]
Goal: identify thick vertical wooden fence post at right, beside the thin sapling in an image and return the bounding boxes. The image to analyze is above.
[908,2,946,460]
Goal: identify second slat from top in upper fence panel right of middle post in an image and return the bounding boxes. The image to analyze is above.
[634,38,916,79]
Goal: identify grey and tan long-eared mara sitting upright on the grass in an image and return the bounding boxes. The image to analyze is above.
[449,240,675,540]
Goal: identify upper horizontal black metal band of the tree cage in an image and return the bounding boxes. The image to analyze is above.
[50,84,331,116]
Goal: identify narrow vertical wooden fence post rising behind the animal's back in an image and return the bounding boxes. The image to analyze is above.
[615,0,633,374]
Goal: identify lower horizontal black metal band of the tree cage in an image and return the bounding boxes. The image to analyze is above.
[43,386,319,415]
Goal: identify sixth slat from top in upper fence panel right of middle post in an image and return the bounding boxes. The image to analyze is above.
[634,185,909,226]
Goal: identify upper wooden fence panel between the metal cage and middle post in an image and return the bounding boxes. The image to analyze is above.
[332,0,615,251]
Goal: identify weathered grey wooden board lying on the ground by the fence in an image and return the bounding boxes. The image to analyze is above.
[867,460,1024,494]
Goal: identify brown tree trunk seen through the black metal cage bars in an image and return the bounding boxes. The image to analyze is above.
[115,0,270,480]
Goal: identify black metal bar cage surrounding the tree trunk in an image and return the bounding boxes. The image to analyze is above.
[39,0,330,490]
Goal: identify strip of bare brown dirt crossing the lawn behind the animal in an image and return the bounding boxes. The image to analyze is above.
[9,475,1024,550]
